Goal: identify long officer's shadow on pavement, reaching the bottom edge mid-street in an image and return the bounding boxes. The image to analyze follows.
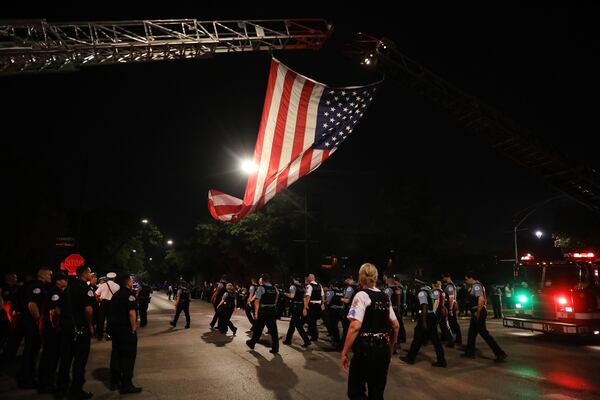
[250,350,298,400]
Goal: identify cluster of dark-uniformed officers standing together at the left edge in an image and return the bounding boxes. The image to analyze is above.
[0,266,152,399]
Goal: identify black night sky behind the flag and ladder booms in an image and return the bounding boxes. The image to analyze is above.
[0,3,600,260]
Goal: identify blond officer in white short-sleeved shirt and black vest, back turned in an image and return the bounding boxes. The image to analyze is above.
[341,263,399,399]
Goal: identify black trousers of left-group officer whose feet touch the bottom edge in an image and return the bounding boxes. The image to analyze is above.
[56,328,90,392]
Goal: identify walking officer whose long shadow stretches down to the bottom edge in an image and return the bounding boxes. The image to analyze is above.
[246,274,279,354]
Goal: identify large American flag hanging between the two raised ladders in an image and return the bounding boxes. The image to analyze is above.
[208,58,377,222]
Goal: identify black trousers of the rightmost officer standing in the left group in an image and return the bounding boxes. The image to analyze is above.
[110,328,137,388]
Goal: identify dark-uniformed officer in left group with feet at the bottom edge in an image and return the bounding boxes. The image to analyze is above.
[56,265,96,399]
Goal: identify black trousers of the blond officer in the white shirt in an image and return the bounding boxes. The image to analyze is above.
[348,337,390,399]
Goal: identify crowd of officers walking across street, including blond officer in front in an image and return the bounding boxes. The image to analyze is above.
[205,264,507,399]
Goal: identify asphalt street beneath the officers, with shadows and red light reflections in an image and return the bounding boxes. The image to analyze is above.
[0,293,600,400]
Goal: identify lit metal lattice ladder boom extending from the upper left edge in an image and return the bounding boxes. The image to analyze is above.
[0,19,332,74]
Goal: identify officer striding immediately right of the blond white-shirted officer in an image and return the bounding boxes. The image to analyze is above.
[400,286,446,368]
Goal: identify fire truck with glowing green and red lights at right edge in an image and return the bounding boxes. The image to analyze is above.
[503,252,600,337]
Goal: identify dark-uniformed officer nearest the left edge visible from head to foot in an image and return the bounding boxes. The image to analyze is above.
[17,267,52,389]
